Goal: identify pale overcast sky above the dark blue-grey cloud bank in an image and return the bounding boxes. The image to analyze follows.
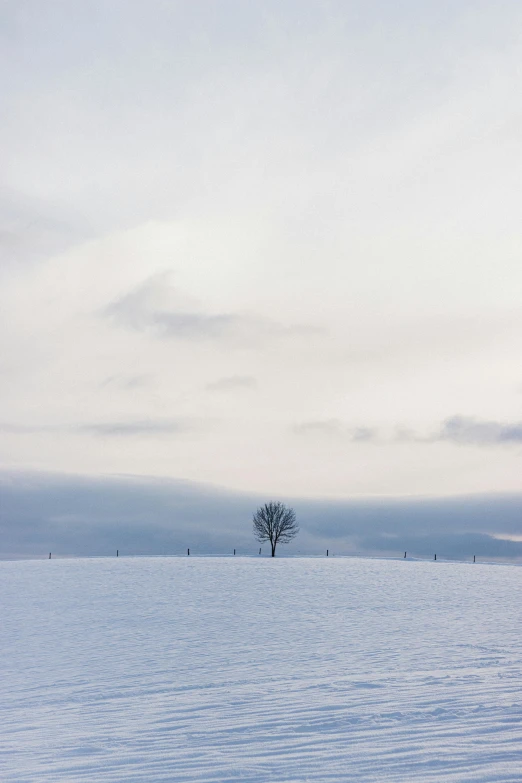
[0,0,522,556]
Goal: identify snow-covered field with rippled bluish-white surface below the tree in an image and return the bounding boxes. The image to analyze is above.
[0,557,522,783]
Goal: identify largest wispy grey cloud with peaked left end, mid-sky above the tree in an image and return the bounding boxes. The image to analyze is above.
[102,272,322,345]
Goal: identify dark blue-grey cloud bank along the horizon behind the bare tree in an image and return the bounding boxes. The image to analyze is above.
[0,472,522,560]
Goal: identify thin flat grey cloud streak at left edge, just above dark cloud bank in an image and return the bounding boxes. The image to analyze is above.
[0,418,203,438]
